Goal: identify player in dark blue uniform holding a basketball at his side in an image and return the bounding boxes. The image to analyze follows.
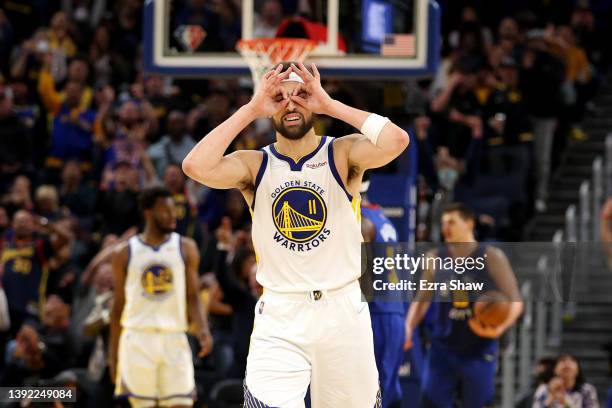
[404,204,523,408]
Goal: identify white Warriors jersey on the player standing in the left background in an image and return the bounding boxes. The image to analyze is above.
[121,232,187,332]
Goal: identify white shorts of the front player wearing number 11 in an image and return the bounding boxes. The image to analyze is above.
[244,282,380,408]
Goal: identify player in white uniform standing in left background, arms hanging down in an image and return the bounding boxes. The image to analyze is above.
[109,187,212,407]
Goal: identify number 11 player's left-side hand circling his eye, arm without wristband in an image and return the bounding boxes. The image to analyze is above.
[249,64,291,117]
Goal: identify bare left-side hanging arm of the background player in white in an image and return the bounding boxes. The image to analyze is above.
[108,242,129,383]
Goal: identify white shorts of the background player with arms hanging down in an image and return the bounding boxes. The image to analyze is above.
[115,329,196,407]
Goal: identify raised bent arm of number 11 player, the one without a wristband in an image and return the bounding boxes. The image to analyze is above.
[183,65,291,188]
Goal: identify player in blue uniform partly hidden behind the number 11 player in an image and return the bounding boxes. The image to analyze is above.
[361,172,420,408]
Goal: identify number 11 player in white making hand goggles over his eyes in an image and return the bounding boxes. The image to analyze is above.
[183,63,408,408]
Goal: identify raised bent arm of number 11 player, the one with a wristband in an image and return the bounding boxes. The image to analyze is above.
[290,62,410,172]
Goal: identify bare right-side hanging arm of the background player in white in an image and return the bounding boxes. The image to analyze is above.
[181,237,213,357]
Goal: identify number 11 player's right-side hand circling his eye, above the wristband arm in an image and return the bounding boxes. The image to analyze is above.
[290,62,333,114]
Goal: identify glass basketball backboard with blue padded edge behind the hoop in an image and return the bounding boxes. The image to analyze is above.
[143,0,440,80]
